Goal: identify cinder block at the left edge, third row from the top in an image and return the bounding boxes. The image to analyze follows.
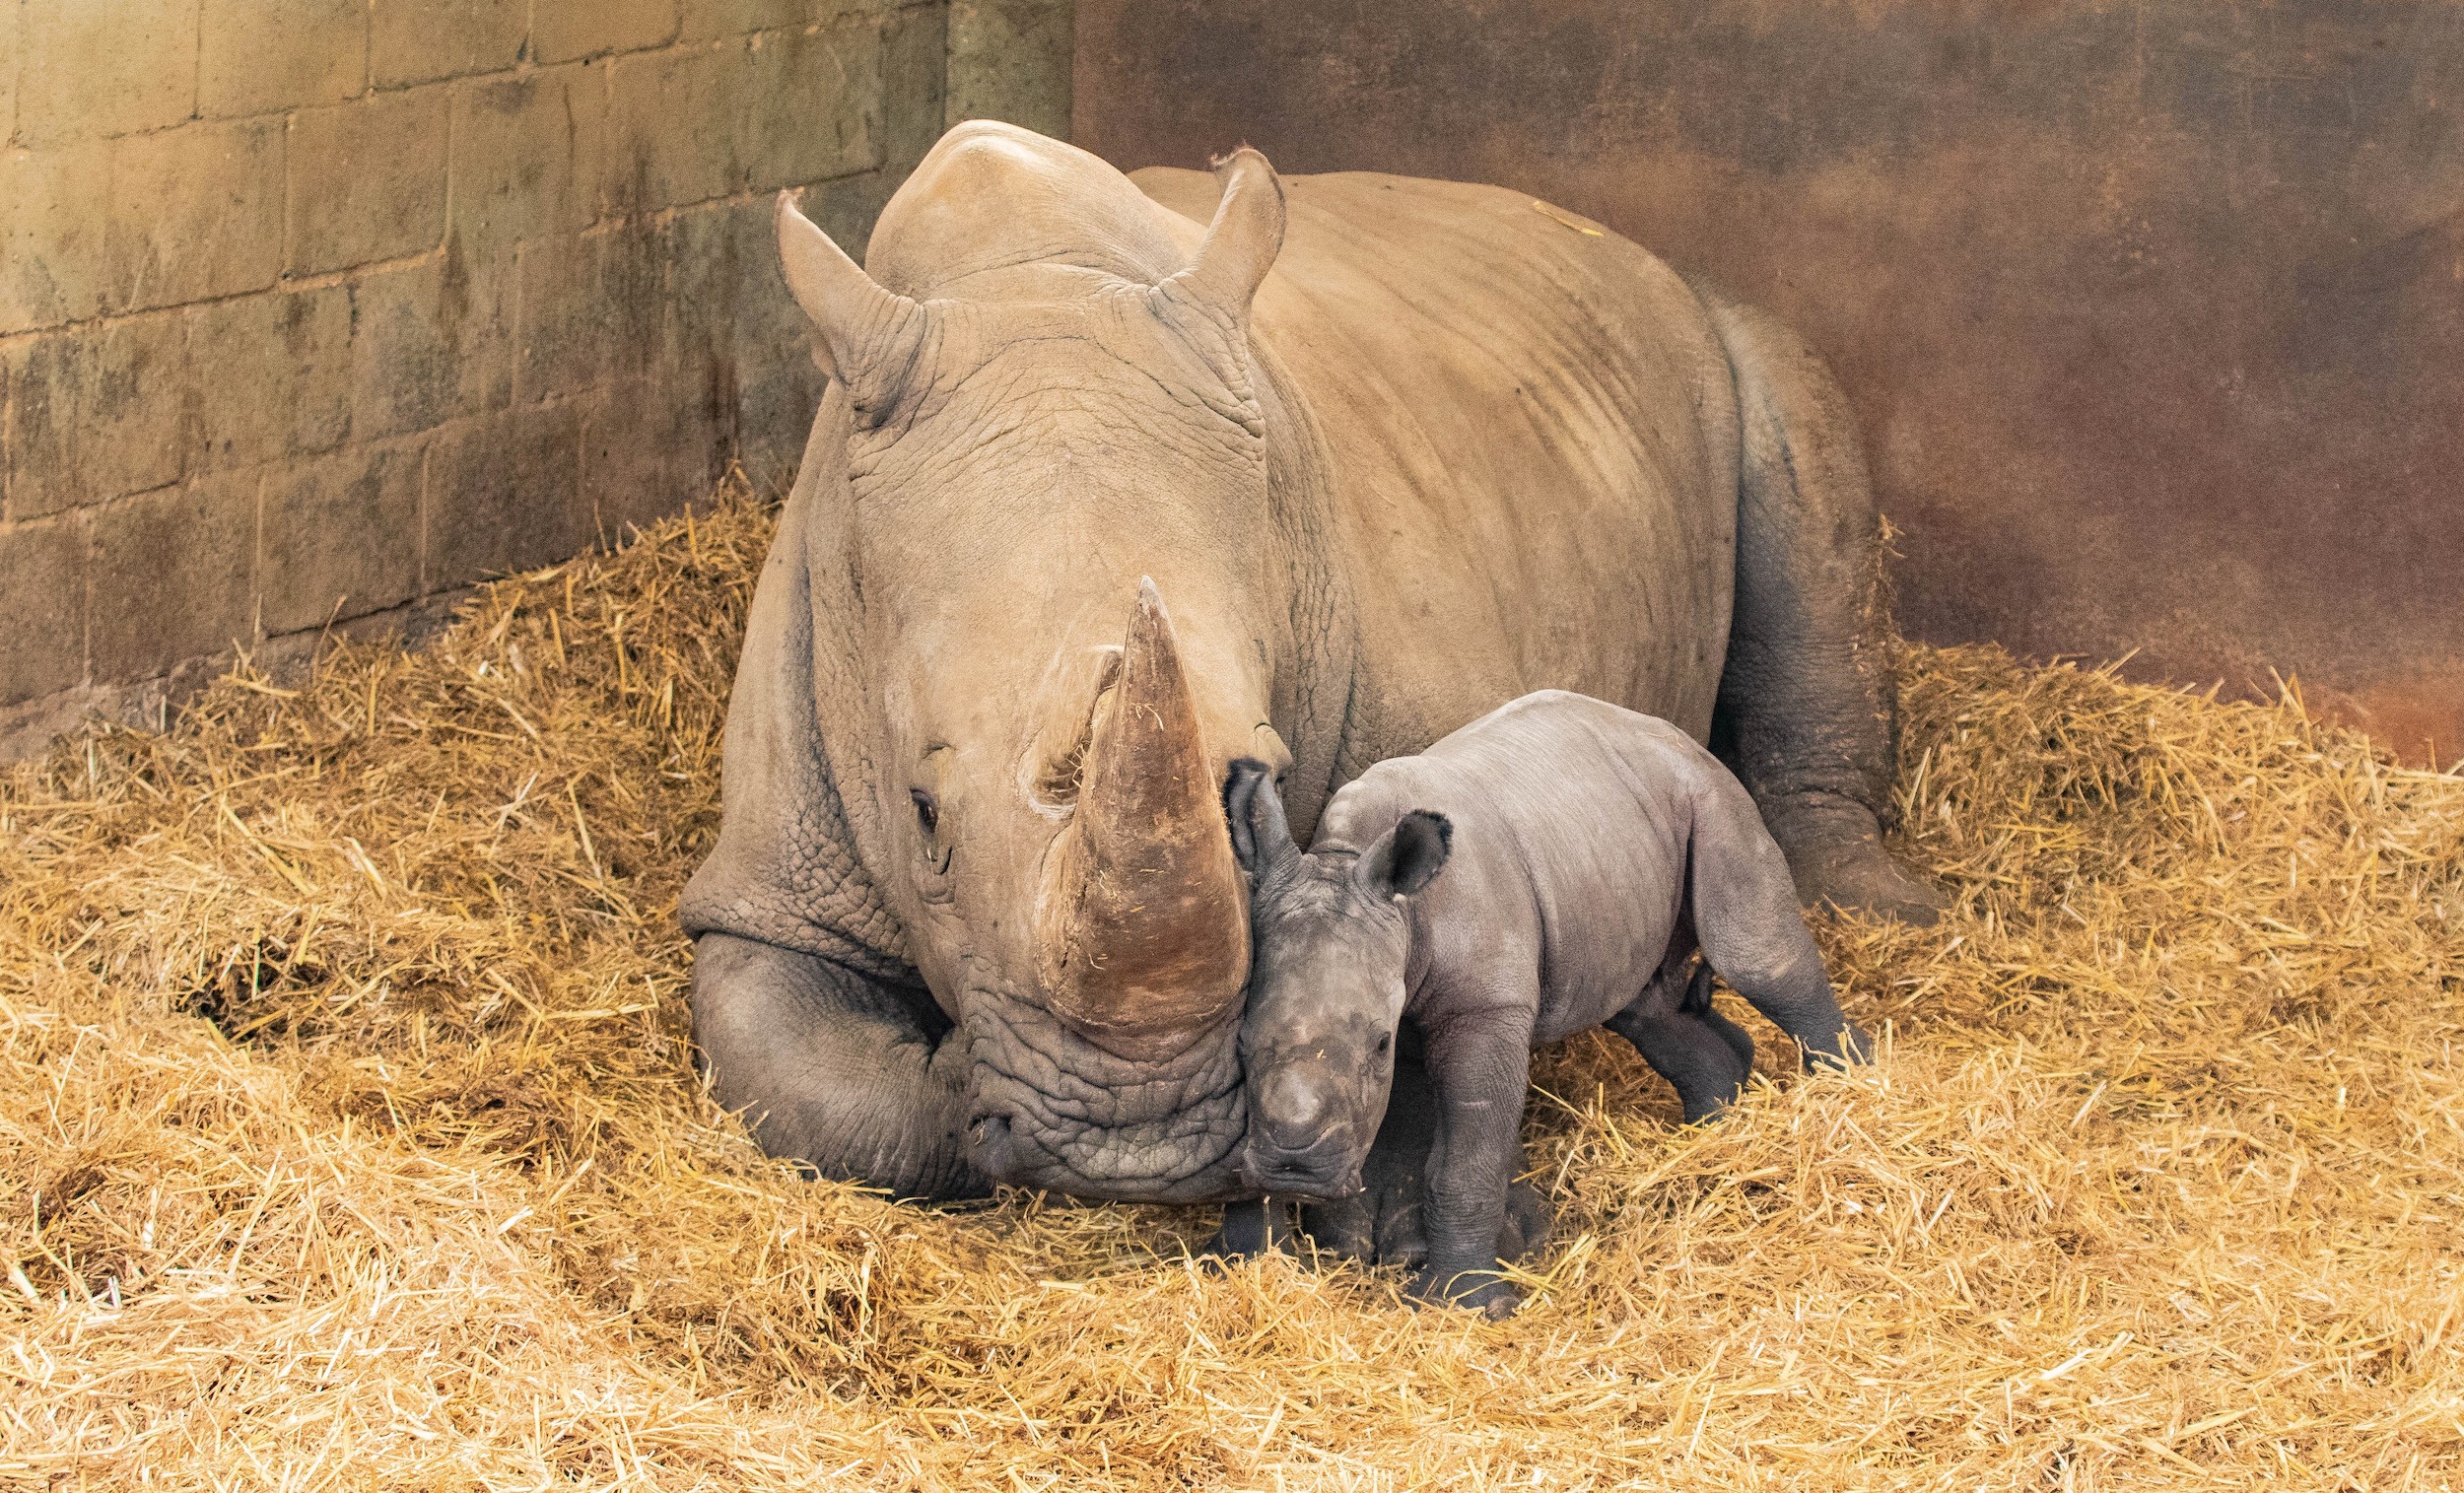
[0,310,187,517]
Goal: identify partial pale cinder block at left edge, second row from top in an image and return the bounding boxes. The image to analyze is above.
[0,144,111,333]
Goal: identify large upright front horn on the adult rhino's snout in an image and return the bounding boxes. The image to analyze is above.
[1035,579,1250,1057]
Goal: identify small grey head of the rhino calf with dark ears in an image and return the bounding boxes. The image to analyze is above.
[1225,762,1452,1197]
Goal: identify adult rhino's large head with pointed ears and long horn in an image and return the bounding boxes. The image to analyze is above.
[779,131,1299,1197]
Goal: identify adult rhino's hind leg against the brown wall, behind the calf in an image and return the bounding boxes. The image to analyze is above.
[1703,291,1942,924]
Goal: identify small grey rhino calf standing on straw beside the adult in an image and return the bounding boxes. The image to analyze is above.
[1225,690,1871,1316]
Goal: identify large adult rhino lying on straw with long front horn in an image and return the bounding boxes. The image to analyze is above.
[683,123,1932,1222]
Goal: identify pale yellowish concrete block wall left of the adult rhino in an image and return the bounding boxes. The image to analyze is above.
[0,0,1069,759]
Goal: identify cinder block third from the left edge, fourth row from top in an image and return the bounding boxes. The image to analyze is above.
[256,443,427,636]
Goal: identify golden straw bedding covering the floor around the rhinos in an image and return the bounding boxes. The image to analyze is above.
[0,493,2464,1488]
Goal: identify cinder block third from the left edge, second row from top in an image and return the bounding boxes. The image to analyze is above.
[286,87,453,274]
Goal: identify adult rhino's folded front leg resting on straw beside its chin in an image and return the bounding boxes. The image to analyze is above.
[693,934,991,1200]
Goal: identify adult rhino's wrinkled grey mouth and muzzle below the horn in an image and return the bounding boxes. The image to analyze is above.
[964,990,1250,1202]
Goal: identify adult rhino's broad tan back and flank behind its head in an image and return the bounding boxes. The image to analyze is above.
[1131,170,1738,767]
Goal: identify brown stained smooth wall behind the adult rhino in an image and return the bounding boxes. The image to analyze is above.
[1077,0,2464,759]
